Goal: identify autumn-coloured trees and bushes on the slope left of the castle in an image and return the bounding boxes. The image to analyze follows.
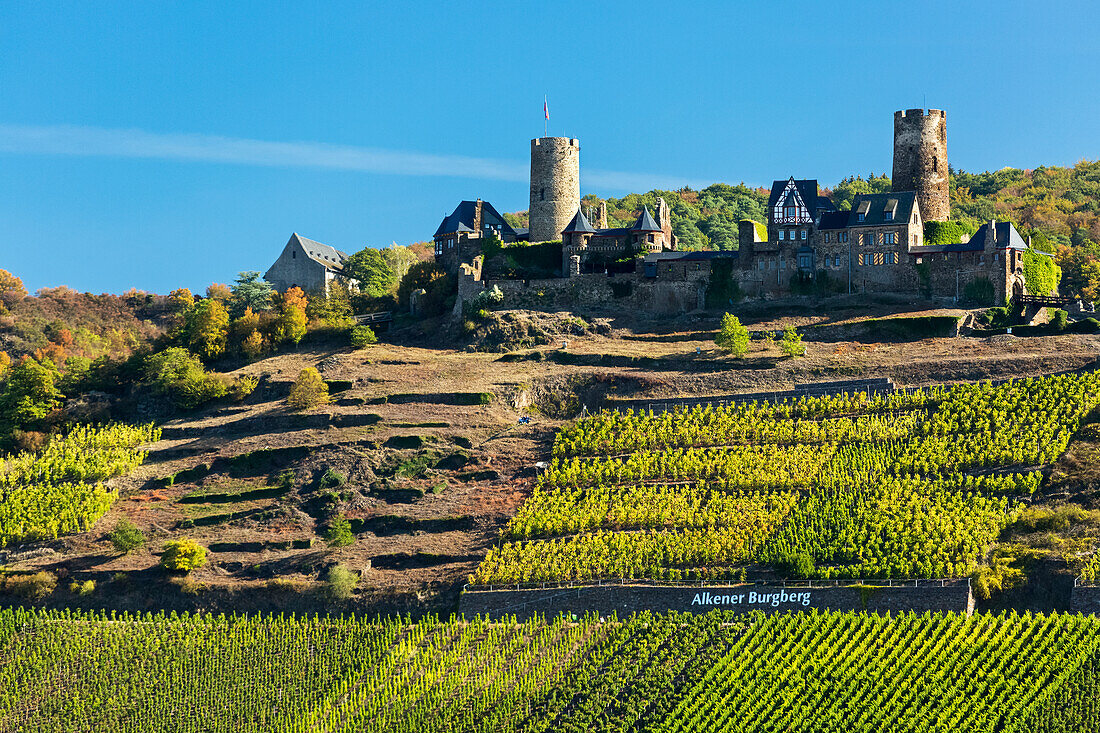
[0,236,454,451]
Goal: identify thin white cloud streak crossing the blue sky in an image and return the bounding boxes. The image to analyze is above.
[0,124,705,192]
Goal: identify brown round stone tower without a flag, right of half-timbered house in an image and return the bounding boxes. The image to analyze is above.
[891,109,952,221]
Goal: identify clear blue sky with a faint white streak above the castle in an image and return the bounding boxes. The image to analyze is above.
[0,0,1100,293]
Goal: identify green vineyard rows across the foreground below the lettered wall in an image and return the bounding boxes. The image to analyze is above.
[0,610,1100,733]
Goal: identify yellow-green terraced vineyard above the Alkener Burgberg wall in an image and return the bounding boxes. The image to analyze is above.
[471,372,1100,584]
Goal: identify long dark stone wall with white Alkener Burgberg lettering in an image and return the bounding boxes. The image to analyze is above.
[459,580,974,619]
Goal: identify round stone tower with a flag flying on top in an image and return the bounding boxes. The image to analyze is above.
[529,138,581,242]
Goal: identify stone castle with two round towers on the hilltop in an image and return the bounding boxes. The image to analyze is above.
[435,109,1042,307]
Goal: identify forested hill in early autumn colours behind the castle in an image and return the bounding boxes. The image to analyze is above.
[509,161,1100,299]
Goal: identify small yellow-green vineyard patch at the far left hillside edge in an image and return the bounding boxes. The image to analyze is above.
[0,425,161,547]
